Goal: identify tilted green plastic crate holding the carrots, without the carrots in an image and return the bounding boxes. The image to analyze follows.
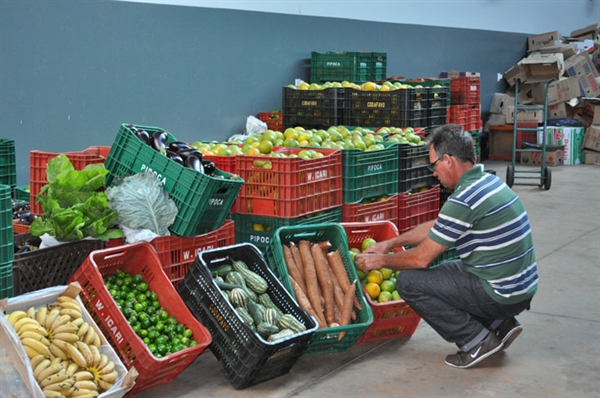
[265,224,373,356]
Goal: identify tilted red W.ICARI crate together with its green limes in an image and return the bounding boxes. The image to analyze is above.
[71,242,211,395]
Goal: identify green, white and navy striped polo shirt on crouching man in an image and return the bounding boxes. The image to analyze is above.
[428,165,538,304]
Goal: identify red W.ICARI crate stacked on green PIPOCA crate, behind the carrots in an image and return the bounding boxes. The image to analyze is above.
[230,147,342,251]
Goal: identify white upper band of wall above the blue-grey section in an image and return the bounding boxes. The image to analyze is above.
[117,0,600,36]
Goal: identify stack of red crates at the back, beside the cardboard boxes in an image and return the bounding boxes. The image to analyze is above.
[449,73,482,131]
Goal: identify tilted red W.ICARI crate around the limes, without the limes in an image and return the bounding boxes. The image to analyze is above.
[70,242,211,396]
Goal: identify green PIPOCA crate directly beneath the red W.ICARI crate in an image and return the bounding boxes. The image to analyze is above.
[231,206,342,251]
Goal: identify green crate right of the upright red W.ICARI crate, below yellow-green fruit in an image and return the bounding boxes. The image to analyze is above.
[342,143,398,203]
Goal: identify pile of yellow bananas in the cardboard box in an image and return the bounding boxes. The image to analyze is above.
[6,295,118,397]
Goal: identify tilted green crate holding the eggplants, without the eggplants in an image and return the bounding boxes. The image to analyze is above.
[104,124,244,236]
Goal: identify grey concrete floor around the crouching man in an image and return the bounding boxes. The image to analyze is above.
[137,161,600,398]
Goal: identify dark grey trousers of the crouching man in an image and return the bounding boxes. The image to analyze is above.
[396,260,531,351]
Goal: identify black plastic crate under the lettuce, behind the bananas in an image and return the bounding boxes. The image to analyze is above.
[13,233,104,296]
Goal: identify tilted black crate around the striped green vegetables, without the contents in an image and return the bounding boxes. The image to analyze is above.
[178,243,317,389]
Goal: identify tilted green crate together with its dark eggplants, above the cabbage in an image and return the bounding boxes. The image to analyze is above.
[104,124,244,236]
